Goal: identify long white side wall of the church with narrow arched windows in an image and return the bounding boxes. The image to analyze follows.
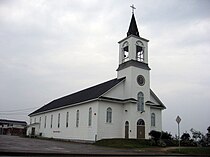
[28,101,98,141]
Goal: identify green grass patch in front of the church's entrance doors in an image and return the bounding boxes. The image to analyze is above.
[95,139,151,148]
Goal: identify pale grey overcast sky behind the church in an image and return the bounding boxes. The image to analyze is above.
[0,0,210,135]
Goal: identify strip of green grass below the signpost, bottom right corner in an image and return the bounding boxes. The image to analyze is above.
[169,147,210,155]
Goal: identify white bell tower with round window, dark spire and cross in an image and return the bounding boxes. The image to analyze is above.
[117,10,150,99]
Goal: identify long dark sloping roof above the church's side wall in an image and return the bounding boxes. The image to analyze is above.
[29,77,125,116]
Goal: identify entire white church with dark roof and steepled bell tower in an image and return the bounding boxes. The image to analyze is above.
[27,10,166,141]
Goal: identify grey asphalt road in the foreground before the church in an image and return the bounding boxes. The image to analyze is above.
[0,135,200,157]
